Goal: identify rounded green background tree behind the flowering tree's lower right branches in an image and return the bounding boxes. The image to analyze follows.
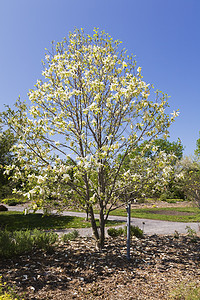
[119,139,184,200]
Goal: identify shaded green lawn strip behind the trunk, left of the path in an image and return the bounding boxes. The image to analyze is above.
[0,211,121,231]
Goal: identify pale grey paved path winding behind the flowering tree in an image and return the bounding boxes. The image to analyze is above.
[7,205,200,236]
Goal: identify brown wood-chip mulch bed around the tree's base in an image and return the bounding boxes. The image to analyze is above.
[0,235,200,300]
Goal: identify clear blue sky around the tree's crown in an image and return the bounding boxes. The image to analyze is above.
[0,0,200,155]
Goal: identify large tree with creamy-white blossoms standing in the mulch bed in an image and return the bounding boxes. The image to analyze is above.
[4,29,177,248]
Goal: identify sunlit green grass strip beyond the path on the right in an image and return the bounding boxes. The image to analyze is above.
[108,207,200,222]
